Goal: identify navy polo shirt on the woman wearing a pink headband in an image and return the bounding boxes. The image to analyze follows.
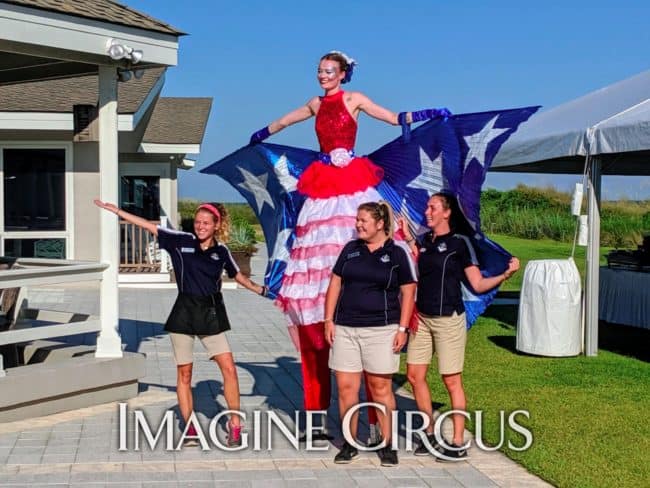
[158,227,239,296]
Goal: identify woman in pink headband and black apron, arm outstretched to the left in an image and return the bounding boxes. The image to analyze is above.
[95,200,266,446]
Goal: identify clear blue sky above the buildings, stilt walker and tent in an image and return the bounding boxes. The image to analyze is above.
[124,0,650,201]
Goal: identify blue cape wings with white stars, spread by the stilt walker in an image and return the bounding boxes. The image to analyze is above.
[201,107,539,327]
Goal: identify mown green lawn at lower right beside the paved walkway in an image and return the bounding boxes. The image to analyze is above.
[394,307,650,487]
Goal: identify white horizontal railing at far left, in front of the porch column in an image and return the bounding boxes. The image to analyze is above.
[0,258,108,377]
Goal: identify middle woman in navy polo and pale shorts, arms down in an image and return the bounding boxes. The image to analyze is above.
[325,202,416,466]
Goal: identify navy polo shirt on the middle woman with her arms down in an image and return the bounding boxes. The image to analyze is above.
[332,239,417,327]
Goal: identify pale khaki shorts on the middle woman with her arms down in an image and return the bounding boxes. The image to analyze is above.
[329,324,399,374]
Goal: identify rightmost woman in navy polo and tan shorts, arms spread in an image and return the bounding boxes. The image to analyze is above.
[400,193,519,460]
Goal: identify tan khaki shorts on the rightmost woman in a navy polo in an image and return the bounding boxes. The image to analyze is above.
[406,312,467,374]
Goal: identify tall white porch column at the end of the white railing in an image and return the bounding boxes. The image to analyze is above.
[95,66,122,358]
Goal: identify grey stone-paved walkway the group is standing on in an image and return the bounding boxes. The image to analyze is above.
[0,250,549,488]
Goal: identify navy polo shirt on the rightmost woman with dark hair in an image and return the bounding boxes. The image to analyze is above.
[417,232,478,316]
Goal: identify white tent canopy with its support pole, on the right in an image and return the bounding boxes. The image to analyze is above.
[491,70,650,355]
